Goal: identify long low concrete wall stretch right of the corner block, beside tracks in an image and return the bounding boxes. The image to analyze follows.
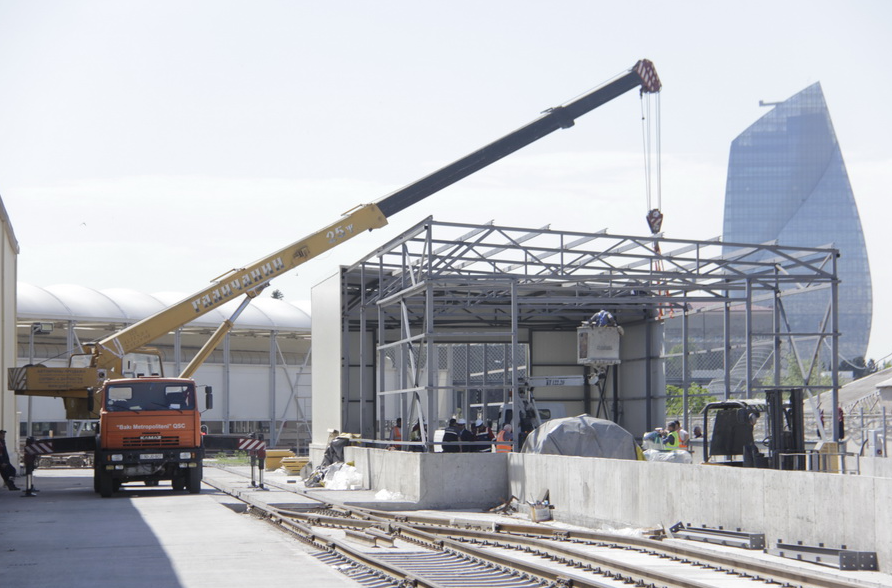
[508,453,892,569]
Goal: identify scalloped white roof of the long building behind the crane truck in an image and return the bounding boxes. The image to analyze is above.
[17,282,310,333]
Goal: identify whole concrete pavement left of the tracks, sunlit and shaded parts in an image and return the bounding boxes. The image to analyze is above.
[0,469,358,588]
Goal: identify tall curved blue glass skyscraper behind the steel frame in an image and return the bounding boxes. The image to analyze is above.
[723,83,873,369]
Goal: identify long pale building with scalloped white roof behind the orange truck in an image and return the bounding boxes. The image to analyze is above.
[12,284,311,451]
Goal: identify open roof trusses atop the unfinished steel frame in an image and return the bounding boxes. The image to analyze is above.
[345,217,838,338]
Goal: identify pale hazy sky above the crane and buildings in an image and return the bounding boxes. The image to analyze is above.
[0,0,892,359]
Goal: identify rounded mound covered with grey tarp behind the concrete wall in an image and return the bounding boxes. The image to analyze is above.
[522,414,638,459]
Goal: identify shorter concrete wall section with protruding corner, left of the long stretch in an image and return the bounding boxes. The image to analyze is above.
[344,447,510,510]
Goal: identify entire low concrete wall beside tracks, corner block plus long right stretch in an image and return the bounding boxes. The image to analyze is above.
[328,447,892,570]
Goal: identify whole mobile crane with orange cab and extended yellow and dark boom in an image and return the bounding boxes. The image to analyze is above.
[8,59,661,497]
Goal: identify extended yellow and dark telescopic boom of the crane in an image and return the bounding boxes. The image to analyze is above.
[9,59,661,418]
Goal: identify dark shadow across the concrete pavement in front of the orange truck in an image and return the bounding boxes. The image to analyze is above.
[0,470,182,588]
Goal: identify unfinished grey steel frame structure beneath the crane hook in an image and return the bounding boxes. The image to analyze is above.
[341,217,839,438]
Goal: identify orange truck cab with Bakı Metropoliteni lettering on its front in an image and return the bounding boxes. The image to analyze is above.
[93,377,211,497]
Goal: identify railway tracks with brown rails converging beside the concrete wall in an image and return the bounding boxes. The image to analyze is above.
[205,468,880,588]
